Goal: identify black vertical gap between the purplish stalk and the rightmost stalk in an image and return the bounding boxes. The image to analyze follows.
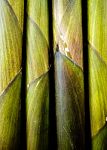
[81,0,91,150]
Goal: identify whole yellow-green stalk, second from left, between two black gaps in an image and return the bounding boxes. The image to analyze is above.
[26,0,49,150]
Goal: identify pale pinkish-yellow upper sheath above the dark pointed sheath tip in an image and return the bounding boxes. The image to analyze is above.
[54,0,82,67]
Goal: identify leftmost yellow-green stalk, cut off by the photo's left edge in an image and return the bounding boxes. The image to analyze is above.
[0,0,24,150]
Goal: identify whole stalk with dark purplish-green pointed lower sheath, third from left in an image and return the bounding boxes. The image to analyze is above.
[54,0,84,150]
